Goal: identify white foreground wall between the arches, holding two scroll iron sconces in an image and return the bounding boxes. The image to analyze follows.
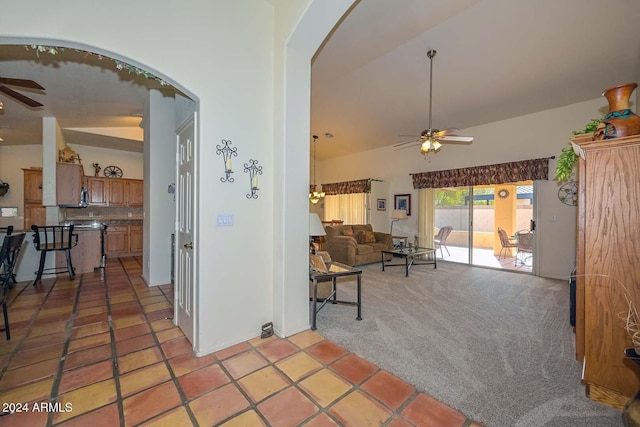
[0,0,360,354]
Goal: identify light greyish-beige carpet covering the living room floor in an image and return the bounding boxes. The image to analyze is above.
[318,262,622,427]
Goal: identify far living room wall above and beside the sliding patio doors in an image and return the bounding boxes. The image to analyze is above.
[318,98,612,278]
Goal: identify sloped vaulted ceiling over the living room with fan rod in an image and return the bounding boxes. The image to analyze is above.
[311,0,640,159]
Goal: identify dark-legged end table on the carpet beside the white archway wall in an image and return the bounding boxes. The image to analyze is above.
[309,262,362,330]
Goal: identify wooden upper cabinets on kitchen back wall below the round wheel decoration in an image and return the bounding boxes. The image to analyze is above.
[86,177,144,207]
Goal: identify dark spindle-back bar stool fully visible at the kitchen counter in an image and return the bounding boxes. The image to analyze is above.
[31,225,78,285]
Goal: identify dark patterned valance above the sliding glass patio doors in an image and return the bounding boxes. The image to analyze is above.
[412,157,549,188]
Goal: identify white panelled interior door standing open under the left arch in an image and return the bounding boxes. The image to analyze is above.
[174,114,196,346]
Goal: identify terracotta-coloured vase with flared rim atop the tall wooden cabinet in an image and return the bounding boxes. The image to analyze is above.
[593,83,640,141]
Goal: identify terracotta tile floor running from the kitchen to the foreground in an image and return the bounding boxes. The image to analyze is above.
[0,258,479,427]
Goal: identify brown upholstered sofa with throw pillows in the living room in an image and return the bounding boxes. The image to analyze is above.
[322,224,393,265]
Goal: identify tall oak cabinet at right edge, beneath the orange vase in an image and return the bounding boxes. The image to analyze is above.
[576,135,640,408]
